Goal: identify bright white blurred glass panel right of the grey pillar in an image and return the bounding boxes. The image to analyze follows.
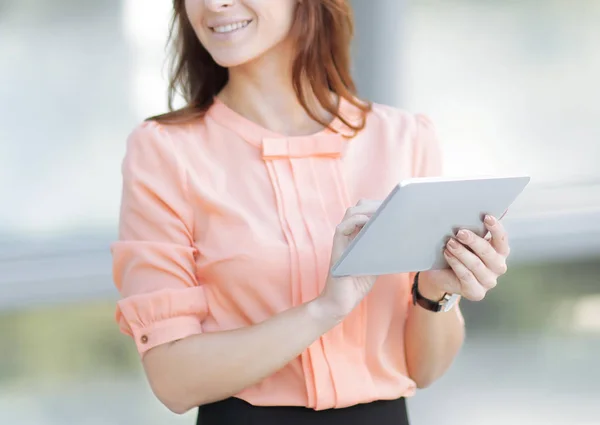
[402,0,600,183]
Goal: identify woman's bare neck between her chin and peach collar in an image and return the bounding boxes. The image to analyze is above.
[219,39,331,136]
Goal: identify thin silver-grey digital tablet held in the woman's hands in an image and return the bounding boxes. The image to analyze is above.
[331,176,530,277]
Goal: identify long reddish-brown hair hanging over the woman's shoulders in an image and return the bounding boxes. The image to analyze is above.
[149,0,371,132]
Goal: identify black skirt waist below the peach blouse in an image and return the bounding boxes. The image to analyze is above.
[196,398,408,425]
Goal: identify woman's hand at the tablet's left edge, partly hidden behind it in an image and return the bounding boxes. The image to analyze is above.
[316,200,381,320]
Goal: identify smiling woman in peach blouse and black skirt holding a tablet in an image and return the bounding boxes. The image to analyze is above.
[113,0,508,425]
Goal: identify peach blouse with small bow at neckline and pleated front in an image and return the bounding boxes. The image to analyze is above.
[112,99,441,410]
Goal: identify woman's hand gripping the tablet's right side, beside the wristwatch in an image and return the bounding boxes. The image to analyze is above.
[419,216,510,301]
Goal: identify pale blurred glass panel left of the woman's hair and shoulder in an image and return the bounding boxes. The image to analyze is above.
[0,0,170,240]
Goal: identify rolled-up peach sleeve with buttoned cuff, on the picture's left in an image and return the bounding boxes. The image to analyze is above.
[111,122,207,355]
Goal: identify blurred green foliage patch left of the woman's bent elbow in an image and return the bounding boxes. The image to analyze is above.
[0,302,140,385]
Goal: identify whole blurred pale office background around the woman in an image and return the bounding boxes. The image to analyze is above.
[0,0,600,425]
